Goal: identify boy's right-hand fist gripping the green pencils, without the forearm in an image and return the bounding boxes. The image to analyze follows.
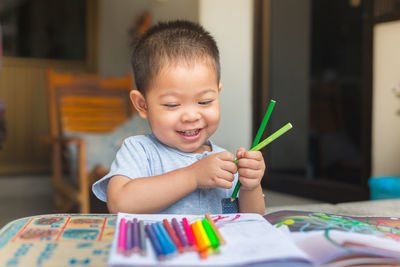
[236,148,265,190]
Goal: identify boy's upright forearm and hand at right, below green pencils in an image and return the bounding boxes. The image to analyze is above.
[237,148,265,215]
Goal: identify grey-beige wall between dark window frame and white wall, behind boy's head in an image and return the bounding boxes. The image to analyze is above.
[98,0,198,76]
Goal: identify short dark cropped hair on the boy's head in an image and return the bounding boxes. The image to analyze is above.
[131,20,221,94]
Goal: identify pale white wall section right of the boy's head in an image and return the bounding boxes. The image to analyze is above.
[199,0,253,152]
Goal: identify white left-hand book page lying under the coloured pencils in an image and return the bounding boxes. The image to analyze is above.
[108,213,310,266]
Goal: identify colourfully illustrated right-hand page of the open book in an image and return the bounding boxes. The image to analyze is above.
[264,210,400,266]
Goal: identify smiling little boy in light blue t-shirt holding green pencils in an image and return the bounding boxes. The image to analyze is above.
[93,21,265,214]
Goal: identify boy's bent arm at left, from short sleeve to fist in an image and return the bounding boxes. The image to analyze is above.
[107,151,237,213]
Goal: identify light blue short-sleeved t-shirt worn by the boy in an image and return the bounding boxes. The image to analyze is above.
[92,134,238,214]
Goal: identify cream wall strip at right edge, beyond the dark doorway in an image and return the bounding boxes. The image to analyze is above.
[372,21,400,176]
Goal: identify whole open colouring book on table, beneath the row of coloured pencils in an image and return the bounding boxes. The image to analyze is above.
[108,211,400,266]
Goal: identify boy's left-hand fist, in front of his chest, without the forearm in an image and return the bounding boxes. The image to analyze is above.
[190,151,237,189]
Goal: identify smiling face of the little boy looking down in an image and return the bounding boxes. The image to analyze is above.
[132,63,221,153]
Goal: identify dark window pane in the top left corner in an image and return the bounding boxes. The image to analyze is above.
[0,0,87,61]
